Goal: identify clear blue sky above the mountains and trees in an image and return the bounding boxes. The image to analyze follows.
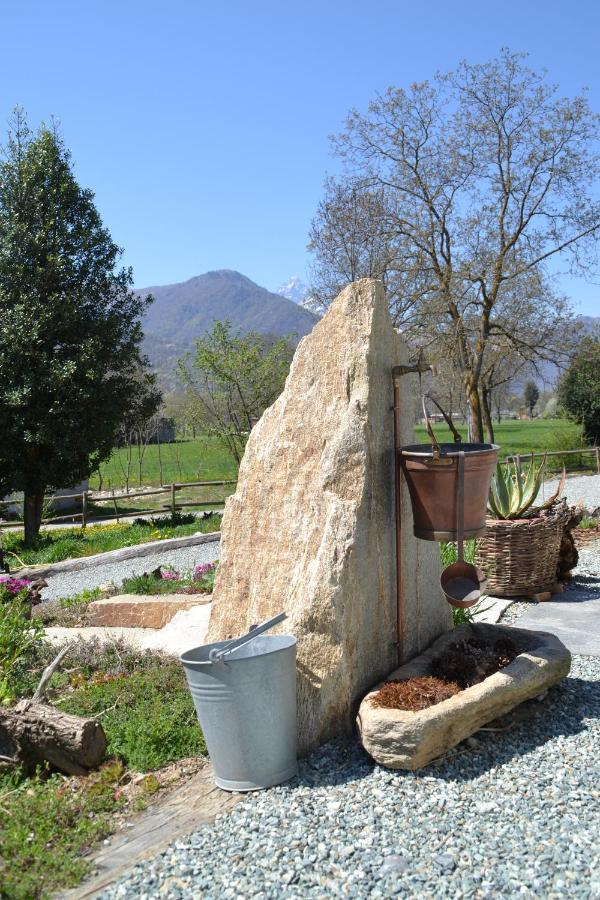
[0,0,600,314]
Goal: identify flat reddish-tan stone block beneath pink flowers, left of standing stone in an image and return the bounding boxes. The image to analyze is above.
[85,594,212,628]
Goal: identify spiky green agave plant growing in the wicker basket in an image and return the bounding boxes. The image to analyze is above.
[488,455,566,519]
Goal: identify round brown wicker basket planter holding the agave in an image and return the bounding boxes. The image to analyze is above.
[475,501,571,597]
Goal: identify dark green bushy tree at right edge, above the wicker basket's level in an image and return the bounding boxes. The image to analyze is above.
[558,338,600,444]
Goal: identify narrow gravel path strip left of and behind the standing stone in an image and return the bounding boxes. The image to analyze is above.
[42,541,221,600]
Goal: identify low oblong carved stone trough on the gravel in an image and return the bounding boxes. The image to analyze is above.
[357,624,571,769]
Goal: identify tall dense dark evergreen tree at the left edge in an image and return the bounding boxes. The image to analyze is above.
[0,110,160,541]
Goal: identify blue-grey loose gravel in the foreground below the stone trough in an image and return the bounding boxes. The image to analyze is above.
[101,657,600,900]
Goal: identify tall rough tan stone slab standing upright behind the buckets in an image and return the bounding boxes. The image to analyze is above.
[208,279,451,751]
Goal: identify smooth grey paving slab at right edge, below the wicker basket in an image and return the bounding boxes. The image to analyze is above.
[518,594,600,656]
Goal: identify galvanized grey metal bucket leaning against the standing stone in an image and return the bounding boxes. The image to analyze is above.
[181,623,298,791]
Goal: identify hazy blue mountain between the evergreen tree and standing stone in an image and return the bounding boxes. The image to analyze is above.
[136,269,318,390]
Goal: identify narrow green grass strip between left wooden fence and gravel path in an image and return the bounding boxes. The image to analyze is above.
[2,515,221,570]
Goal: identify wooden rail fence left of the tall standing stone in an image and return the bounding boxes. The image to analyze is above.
[0,479,237,528]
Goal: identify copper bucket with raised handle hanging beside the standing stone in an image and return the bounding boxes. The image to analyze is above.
[398,398,500,541]
